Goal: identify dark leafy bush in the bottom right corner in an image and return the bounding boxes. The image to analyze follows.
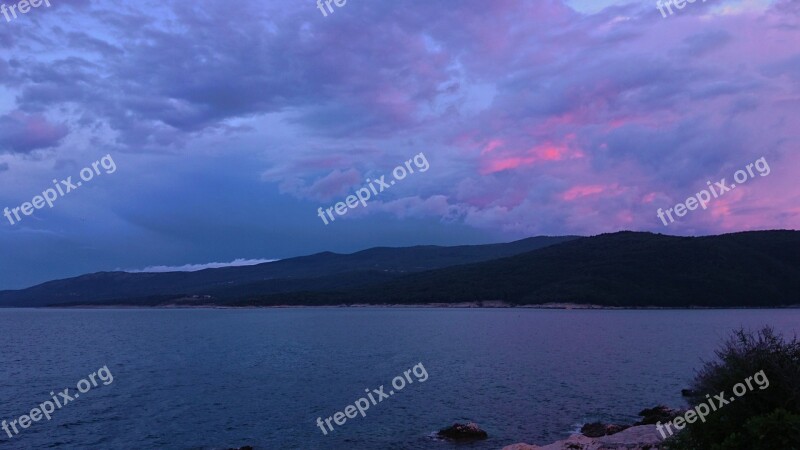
[668,327,800,450]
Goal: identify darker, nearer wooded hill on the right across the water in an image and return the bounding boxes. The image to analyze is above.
[225,231,800,307]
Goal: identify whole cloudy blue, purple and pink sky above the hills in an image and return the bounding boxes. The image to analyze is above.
[0,0,800,289]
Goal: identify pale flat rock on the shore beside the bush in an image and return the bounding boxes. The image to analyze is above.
[503,425,662,450]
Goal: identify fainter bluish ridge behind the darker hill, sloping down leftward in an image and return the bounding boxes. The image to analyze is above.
[0,236,578,307]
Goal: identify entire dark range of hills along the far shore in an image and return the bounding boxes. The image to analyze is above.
[0,230,800,307]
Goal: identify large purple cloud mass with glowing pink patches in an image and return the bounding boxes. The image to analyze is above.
[0,0,800,243]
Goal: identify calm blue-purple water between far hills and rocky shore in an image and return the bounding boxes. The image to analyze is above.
[0,308,800,450]
